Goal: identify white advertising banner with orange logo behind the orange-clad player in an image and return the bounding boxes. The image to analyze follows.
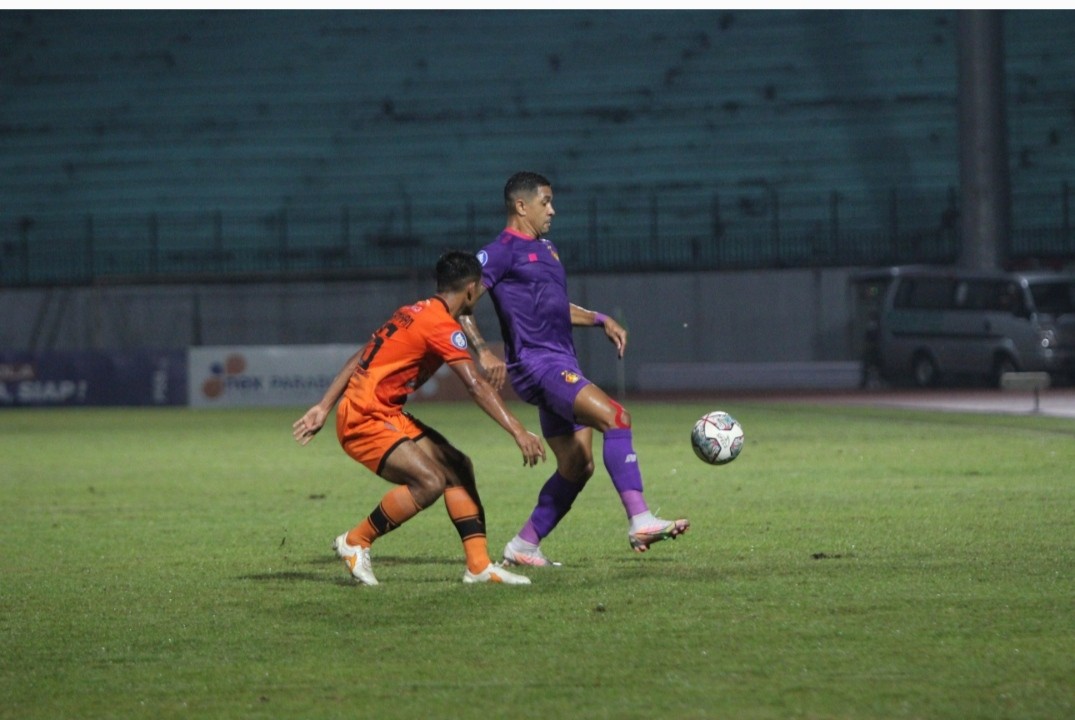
[187,345,358,407]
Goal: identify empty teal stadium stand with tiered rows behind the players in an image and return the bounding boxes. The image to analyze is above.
[0,11,1075,286]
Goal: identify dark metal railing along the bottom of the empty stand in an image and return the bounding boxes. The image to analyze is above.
[0,181,1075,287]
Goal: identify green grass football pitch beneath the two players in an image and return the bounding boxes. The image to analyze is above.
[0,401,1075,720]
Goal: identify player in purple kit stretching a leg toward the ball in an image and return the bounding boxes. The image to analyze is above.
[459,172,690,566]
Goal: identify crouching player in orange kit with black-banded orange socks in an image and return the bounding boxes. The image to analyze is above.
[292,251,545,585]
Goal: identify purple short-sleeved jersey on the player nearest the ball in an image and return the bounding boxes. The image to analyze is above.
[477,229,575,375]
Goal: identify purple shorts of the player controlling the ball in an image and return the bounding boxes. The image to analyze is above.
[512,356,590,437]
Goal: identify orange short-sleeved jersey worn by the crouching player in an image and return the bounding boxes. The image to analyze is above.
[342,298,471,416]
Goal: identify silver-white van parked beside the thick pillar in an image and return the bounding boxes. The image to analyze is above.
[863,267,1075,387]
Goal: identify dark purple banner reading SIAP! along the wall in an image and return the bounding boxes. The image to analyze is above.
[0,350,187,407]
